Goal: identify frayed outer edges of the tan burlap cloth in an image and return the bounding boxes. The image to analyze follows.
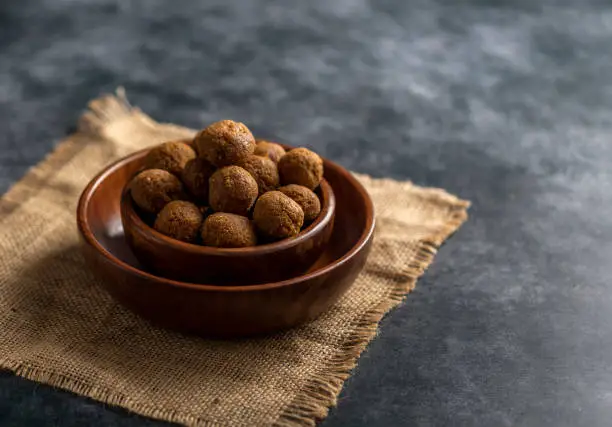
[0,88,470,427]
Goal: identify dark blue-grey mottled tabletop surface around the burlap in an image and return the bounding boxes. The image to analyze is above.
[0,0,612,427]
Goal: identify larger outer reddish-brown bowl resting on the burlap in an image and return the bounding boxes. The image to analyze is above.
[77,147,374,337]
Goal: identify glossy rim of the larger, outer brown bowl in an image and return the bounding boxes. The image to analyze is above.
[76,147,375,292]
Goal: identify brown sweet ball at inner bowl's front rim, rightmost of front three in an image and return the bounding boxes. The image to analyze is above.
[253,191,304,239]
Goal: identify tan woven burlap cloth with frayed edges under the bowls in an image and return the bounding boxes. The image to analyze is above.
[0,94,468,427]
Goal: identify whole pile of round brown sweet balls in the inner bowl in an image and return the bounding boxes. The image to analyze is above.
[128,120,323,248]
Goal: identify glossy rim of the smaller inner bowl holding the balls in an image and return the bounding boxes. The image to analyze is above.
[120,171,336,258]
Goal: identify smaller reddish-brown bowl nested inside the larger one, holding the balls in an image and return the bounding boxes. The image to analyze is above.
[121,151,336,285]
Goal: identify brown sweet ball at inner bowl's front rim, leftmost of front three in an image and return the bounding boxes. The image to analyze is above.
[153,200,202,242]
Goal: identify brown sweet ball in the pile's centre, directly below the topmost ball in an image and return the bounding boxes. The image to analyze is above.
[208,166,258,216]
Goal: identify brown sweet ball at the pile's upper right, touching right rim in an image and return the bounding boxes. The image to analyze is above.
[278,148,323,190]
